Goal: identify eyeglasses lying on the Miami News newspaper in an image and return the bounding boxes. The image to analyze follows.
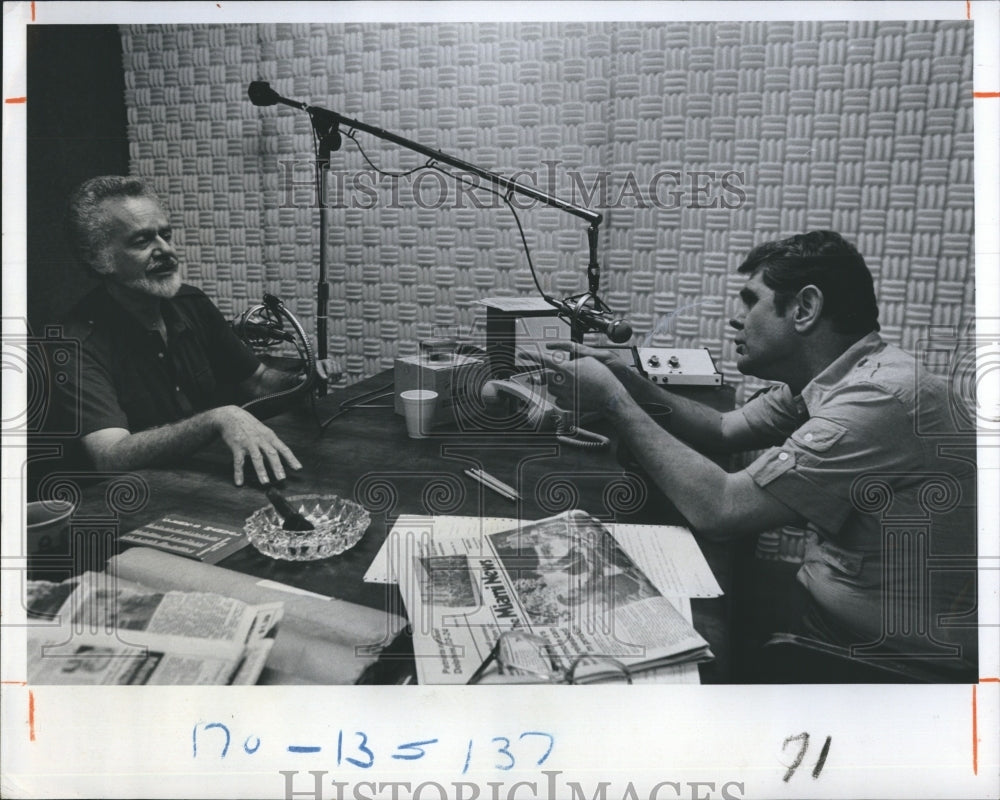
[468,630,632,684]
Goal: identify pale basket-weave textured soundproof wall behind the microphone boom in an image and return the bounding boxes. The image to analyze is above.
[122,22,974,400]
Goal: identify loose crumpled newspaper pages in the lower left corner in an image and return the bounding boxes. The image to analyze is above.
[27,572,282,685]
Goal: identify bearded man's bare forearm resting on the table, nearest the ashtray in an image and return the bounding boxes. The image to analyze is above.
[88,409,219,470]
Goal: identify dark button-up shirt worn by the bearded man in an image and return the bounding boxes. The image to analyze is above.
[57,284,260,436]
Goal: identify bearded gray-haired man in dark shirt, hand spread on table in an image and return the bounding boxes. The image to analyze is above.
[57,175,301,485]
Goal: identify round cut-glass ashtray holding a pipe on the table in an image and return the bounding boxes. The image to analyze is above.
[243,494,371,561]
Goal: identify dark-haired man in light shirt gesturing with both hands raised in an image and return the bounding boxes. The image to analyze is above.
[546,231,976,680]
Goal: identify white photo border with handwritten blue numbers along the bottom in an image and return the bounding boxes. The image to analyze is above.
[0,0,1000,800]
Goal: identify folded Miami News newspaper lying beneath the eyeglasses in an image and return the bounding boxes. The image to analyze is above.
[398,511,712,683]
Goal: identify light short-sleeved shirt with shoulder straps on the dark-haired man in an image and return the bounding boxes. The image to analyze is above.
[741,333,975,664]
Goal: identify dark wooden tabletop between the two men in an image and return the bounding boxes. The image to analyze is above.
[50,372,733,682]
